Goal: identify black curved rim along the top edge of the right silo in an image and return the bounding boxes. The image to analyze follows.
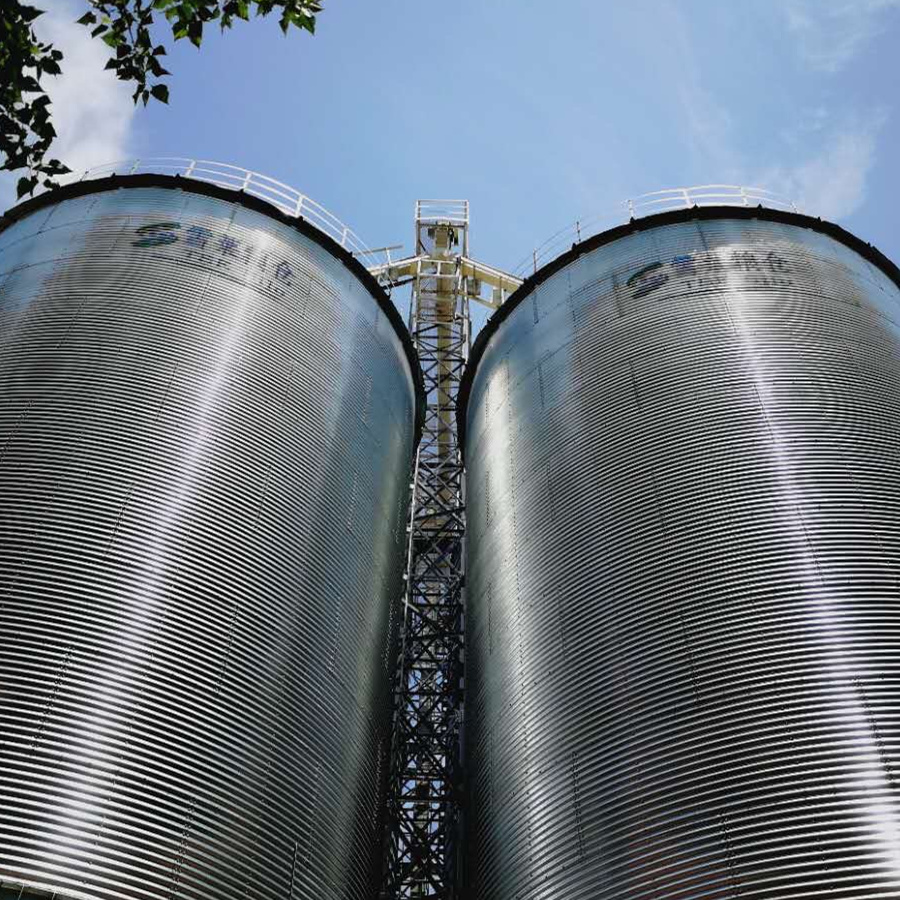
[456,206,900,455]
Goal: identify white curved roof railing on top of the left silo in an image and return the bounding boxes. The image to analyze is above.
[72,156,393,266]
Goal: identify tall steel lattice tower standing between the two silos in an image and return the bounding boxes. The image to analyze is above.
[374,200,520,900]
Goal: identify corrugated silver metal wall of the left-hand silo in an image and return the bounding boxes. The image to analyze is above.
[0,181,415,900]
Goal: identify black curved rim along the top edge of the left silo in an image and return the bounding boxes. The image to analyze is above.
[0,173,425,447]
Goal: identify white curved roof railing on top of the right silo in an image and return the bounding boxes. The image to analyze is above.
[513,184,801,278]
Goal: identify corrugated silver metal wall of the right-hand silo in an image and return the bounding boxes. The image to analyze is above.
[465,212,900,900]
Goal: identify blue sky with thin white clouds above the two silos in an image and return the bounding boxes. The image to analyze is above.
[7,0,900,330]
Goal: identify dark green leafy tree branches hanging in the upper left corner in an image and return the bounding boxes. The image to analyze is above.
[0,0,322,197]
